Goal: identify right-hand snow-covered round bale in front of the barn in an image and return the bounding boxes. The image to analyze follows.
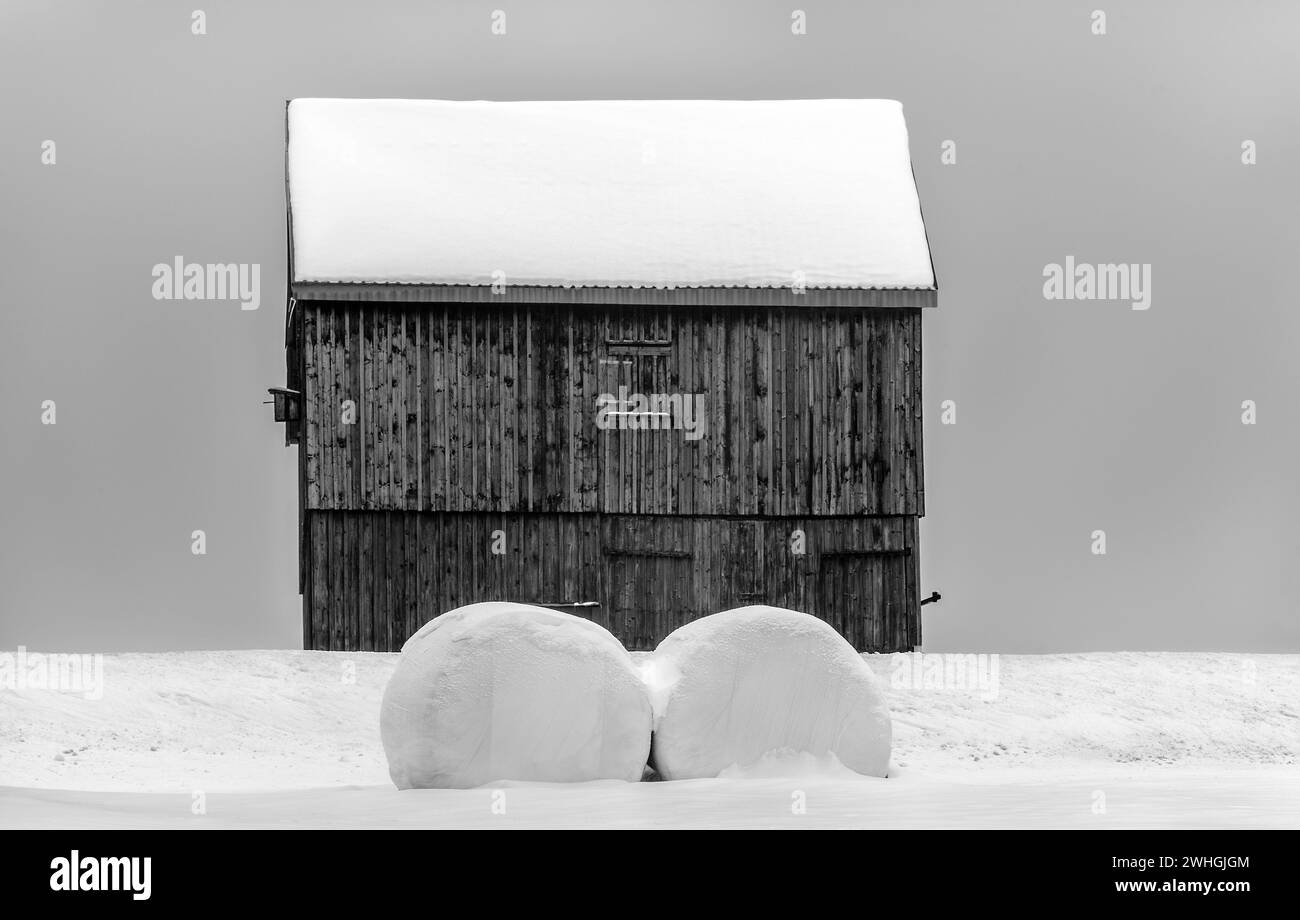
[644,606,891,780]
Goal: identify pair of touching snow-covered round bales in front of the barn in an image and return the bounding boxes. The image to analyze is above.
[381,603,891,789]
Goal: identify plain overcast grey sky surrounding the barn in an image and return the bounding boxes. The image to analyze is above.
[0,0,1300,652]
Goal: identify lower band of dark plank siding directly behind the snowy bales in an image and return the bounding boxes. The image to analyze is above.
[303,511,920,651]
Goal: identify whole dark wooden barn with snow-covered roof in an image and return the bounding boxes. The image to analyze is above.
[272,99,937,651]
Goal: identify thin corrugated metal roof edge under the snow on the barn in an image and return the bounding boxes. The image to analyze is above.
[293,281,939,307]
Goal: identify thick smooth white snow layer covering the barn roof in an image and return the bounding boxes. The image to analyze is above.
[289,99,935,288]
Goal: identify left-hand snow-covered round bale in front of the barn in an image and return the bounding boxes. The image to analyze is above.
[380,603,651,789]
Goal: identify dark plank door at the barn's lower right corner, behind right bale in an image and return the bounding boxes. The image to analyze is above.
[811,550,910,651]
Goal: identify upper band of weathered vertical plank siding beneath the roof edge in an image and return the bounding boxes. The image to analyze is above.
[298,301,924,516]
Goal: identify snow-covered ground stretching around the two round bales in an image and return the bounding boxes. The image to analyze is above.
[0,651,1300,828]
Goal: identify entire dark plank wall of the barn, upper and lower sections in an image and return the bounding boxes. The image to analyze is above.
[299,303,924,651]
